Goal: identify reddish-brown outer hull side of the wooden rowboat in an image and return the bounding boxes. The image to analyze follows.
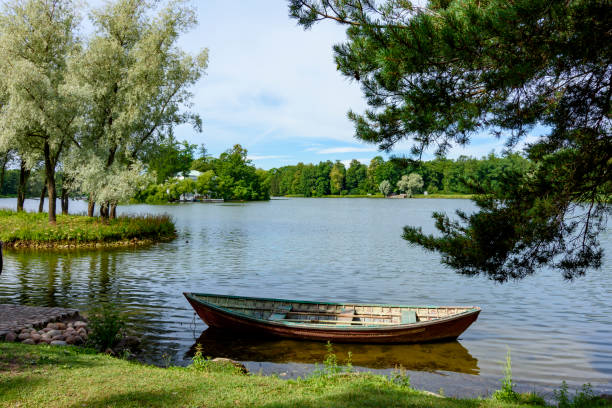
[184,293,480,343]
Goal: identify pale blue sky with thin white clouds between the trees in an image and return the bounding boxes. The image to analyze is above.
[90,0,532,169]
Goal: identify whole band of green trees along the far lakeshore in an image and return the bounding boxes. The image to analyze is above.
[0,149,532,204]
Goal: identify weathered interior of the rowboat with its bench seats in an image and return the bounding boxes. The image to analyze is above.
[193,294,473,326]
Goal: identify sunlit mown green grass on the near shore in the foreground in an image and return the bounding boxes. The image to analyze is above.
[0,343,588,408]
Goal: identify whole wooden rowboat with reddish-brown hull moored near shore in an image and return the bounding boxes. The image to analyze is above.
[183,293,480,343]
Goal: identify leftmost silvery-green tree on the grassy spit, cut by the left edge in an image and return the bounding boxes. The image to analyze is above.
[0,0,81,223]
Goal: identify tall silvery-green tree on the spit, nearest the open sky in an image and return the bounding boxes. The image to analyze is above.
[72,0,208,217]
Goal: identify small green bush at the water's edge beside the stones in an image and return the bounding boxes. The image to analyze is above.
[87,303,125,351]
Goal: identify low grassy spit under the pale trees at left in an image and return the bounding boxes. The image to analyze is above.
[0,209,176,248]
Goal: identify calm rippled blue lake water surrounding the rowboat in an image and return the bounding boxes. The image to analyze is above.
[0,199,612,396]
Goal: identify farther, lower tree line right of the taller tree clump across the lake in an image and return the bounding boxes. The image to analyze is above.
[268,154,531,197]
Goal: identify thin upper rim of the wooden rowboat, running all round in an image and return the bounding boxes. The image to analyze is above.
[183,292,481,331]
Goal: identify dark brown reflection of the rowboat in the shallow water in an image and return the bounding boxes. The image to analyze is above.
[186,327,480,375]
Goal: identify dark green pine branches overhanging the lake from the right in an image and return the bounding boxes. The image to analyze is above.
[289,0,612,281]
